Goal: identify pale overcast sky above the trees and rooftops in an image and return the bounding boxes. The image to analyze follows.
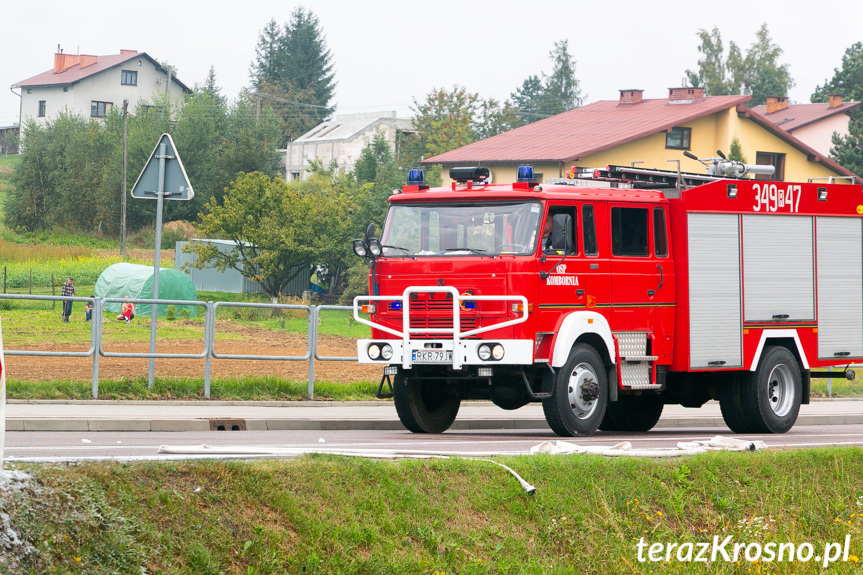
[0,0,863,126]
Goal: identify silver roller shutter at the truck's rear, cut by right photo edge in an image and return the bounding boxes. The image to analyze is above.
[816,217,863,359]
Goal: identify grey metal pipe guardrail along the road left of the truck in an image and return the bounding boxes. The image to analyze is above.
[0,294,357,399]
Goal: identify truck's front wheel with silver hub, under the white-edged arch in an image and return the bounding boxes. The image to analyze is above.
[542,344,608,437]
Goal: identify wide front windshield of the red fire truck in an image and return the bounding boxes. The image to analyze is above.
[382,201,542,257]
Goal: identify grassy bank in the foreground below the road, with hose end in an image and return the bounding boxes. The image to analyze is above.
[5,448,863,575]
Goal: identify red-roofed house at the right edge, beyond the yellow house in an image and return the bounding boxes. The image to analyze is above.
[752,94,860,156]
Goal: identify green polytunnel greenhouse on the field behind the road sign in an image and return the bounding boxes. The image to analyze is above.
[94,263,198,317]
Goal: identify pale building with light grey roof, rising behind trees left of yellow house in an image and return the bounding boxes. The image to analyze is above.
[284,111,413,182]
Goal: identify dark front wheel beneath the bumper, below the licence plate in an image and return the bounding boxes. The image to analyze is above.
[393,373,461,433]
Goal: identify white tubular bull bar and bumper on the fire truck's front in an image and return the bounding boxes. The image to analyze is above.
[354,286,533,369]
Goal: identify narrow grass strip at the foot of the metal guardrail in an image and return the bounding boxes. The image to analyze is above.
[6,376,378,401]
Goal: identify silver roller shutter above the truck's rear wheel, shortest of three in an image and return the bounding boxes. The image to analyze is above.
[743,215,815,322]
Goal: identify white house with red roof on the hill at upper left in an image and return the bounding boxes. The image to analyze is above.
[12,50,191,126]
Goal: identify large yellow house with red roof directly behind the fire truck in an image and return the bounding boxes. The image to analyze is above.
[422,87,855,181]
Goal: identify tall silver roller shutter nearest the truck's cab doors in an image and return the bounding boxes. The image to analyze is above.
[688,214,743,369]
